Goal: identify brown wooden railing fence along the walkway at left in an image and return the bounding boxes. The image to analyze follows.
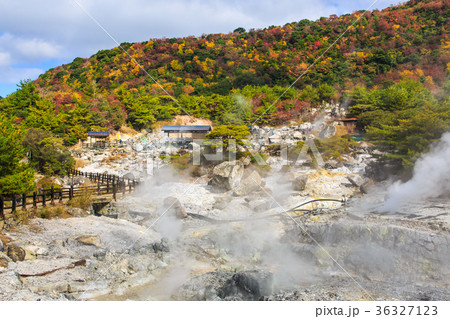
[0,170,139,220]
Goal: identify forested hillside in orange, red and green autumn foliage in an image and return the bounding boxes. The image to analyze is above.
[0,0,450,149]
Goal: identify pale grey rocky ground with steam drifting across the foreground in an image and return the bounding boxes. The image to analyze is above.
[0,154,450,300]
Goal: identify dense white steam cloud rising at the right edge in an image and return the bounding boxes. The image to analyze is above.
[383,132,450,212]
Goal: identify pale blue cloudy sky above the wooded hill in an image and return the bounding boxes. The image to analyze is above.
[0,0,400,97]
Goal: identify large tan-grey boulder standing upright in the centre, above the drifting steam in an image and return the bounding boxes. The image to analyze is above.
[210,162,244,191]
